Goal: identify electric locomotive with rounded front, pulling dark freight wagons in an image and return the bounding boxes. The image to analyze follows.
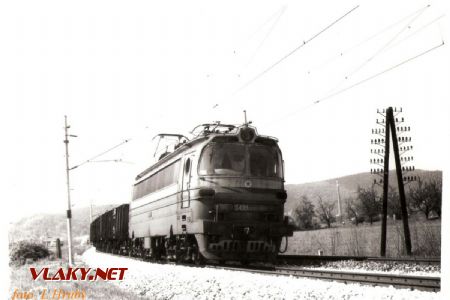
[91,123,292,262]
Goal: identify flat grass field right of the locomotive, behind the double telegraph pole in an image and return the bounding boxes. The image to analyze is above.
[286,220,441,257]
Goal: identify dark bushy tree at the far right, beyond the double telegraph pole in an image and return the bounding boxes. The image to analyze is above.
[408,178,442,219]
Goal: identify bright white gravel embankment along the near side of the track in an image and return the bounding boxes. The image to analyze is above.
[82,248,443,300]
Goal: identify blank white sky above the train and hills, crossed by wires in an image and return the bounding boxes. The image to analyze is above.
[0,0,450,221]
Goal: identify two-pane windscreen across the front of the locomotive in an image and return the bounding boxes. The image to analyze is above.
[199,143,283,178]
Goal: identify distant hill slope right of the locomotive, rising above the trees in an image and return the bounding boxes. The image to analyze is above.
[285,170,442,212]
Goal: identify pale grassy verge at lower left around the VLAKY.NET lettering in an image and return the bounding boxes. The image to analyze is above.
[10,247,143,299]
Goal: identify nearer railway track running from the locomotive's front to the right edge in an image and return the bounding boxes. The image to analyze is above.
[213,265,441,292]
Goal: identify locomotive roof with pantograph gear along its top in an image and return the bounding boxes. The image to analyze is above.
[135,124,278,180]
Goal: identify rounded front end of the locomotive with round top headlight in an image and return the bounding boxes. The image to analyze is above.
[192,126,292,262]
